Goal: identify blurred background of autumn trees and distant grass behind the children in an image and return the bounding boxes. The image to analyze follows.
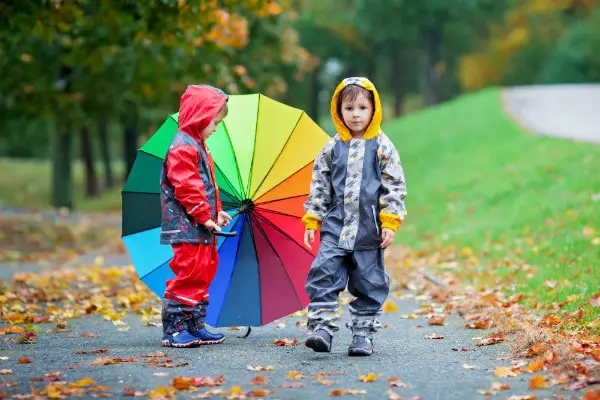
[0,0,600,211]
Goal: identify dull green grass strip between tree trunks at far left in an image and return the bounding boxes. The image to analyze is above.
[0,158,123,212]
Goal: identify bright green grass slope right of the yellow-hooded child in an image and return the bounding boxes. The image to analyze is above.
[384,89,600,318]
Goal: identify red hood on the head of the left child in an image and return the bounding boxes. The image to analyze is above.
[179,85,227,140]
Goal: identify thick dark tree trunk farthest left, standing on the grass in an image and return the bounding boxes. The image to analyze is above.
[52,125,74,210]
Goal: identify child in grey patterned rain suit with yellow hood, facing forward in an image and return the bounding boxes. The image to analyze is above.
[302,77,406,356]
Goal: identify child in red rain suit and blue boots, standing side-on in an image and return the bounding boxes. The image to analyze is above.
[160,85,231,347]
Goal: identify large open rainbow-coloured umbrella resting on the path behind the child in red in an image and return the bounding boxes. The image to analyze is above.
[122,94,329,327]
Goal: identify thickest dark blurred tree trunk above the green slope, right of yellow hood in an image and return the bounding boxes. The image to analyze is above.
[420,28,442,106]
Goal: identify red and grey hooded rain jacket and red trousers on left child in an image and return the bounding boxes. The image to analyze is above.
[161,86,227,306]
